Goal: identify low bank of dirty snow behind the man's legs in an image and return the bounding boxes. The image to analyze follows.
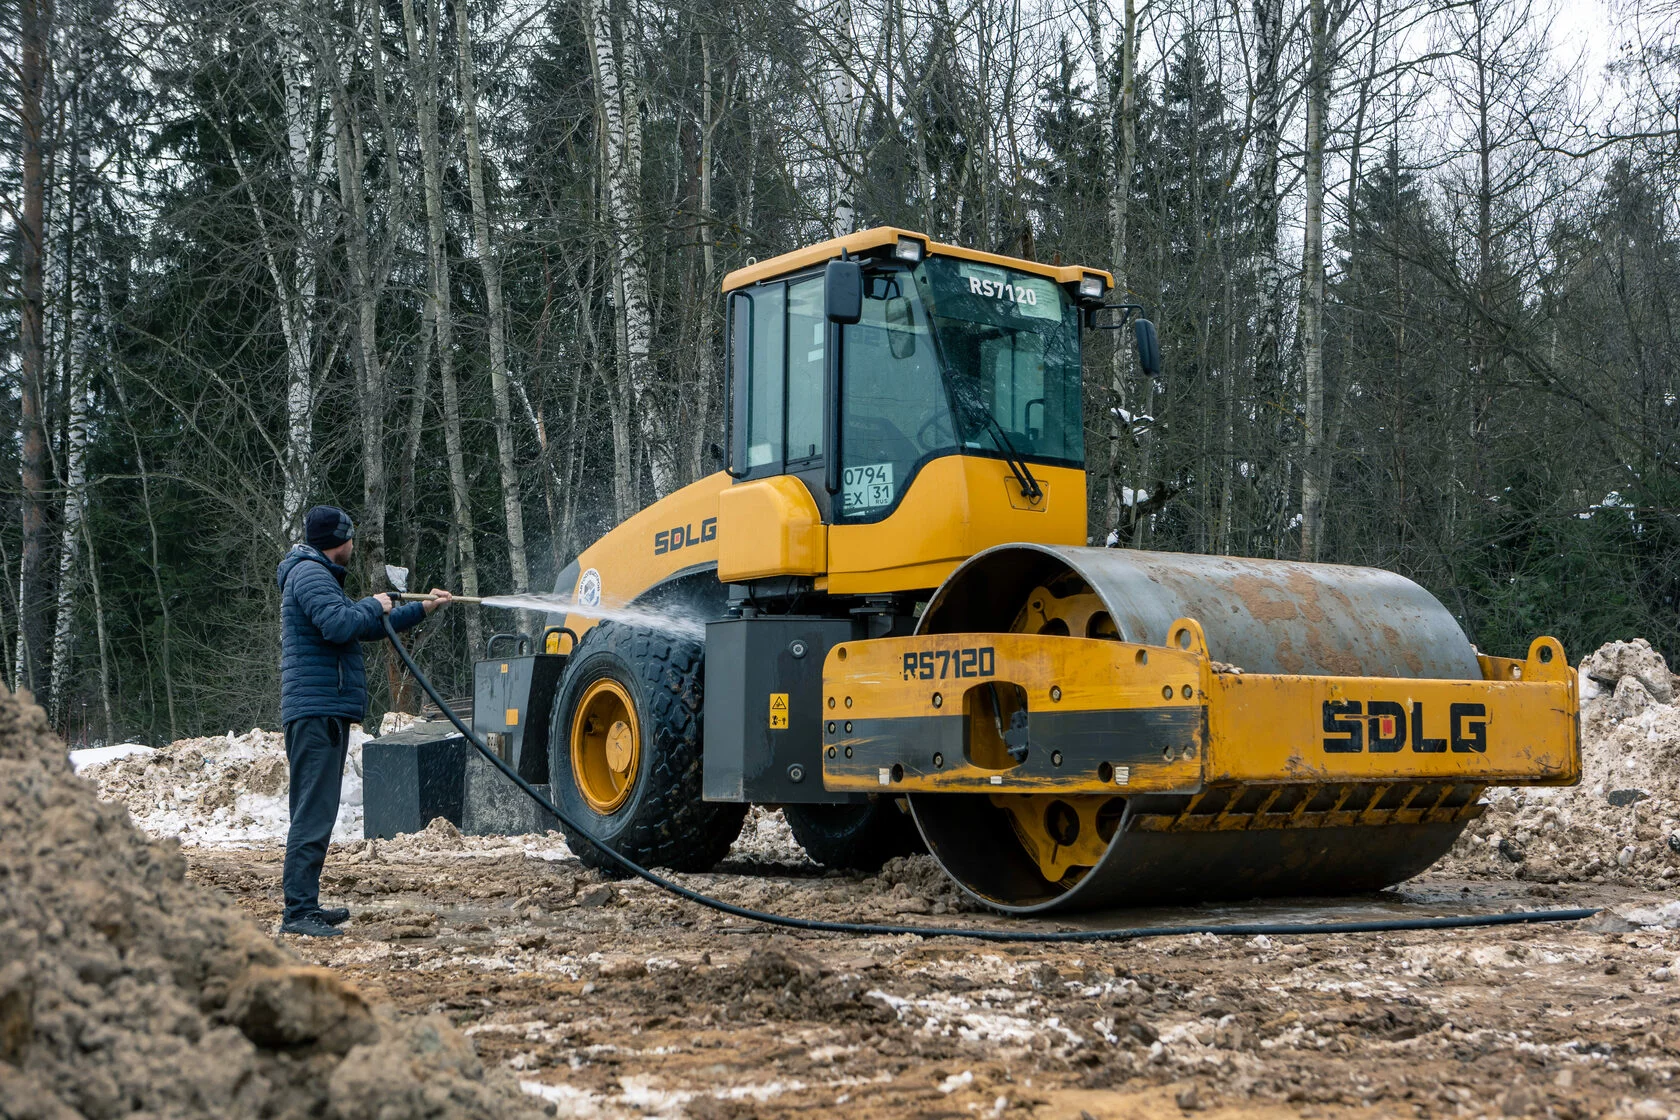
[72,727,370,848]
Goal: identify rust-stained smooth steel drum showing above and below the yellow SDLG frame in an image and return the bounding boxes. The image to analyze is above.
[911,544,1482,913]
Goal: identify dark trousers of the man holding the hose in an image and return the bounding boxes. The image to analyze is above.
[282,715,349,922]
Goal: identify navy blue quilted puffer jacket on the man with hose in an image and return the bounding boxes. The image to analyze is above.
[277,544,425,724]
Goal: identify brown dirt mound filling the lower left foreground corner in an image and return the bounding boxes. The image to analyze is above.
[0,688,543,1120]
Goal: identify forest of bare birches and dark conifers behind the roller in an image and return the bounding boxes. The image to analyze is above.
[0,0,1680,741]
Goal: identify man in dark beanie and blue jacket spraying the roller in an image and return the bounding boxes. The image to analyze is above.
[277,505,450,937]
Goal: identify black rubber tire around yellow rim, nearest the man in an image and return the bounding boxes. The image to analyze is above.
[548,623,748,877]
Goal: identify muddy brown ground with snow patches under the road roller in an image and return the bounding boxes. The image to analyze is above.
[186,838,1680,1120]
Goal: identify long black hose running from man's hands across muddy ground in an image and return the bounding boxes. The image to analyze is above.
[383,615,1598,942]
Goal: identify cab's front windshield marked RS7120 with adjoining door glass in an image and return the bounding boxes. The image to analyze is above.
[840,257,1085,521]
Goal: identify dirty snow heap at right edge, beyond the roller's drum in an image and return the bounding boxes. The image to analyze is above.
[1435,638,1680,887]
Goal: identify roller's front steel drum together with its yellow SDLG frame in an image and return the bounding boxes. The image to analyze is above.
[823,546,1581,912]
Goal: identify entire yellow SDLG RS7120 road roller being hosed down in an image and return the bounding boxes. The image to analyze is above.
[474,228,1579,913]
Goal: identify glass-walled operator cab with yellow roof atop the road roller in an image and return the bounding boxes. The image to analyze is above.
[724,228,1112,526]
